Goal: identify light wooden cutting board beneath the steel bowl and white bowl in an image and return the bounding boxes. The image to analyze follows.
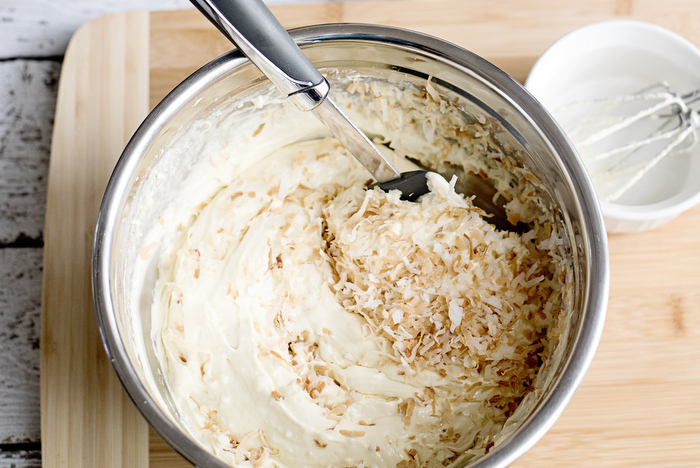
[41,0,700,468]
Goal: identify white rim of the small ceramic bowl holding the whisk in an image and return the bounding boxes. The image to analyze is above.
[525,19,700,226]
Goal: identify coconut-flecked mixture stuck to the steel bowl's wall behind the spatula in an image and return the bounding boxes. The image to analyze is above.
[346,80,553,229]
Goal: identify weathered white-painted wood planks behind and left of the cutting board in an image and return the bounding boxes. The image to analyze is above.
[0,0,328,468]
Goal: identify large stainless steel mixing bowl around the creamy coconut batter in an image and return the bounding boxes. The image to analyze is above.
[93,24,608,467]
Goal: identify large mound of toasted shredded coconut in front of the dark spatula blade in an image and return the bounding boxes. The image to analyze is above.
[324,174,564,450]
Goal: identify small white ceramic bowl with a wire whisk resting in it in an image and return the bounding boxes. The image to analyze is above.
[525,21,700,233]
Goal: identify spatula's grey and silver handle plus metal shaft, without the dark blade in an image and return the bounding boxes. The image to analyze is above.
[191,0,401,183]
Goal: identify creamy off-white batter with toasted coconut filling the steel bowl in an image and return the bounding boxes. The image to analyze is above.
[142,78,570,468]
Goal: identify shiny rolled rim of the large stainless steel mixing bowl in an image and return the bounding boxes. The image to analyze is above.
[92,23,609,468]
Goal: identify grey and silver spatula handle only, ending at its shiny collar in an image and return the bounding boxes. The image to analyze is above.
[191,0,329,111]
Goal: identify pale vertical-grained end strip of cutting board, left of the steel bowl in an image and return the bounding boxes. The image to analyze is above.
[41,13,148,468]
